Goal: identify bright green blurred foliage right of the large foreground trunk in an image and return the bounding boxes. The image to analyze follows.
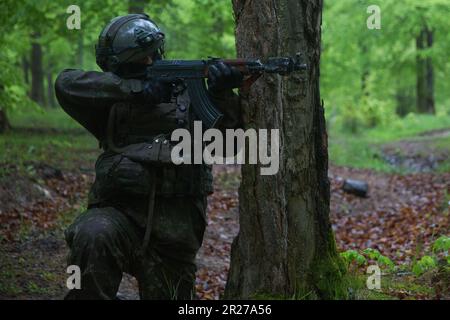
[321,0,450,133]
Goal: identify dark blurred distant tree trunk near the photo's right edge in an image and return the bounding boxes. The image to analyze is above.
[416,26,435,114]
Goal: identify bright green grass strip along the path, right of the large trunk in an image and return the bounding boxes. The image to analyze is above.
[329,115,450,173]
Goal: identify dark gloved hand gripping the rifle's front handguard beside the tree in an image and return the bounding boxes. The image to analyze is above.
[208,61,243,94]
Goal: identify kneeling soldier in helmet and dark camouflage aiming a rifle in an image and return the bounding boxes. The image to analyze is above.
[55,14,242,299]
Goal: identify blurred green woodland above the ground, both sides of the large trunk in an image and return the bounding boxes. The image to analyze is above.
[0,0,450,133]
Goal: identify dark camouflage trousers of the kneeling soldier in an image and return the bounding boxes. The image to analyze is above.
[65,197,206,300]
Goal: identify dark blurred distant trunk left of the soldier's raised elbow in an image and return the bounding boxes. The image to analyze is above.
[31,32,45,105]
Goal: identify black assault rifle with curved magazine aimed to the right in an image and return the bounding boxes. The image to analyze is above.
[146,53,307,128]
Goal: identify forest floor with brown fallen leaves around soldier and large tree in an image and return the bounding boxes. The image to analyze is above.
[0,110,450,299]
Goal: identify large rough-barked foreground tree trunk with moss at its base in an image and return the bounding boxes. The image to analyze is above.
[225,0,346,298]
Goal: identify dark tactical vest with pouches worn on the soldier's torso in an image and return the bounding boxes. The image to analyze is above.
[89,89,213,209]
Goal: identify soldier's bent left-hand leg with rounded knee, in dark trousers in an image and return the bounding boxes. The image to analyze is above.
[65,207,138,300]
